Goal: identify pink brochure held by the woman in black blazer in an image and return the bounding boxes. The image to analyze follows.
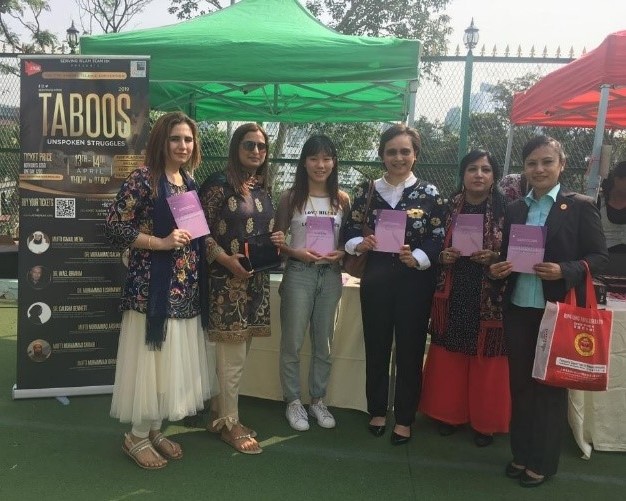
[506,224,546,274]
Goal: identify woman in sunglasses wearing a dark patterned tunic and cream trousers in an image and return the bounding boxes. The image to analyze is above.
[200,123,285,454]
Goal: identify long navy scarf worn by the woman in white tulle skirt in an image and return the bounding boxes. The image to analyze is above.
[146,170,209,350]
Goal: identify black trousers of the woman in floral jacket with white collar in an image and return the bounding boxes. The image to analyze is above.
[360,252,435,426]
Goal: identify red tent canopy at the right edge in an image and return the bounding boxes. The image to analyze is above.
[511,30,626,129]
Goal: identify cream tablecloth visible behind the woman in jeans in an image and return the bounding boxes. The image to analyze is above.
[240,275,367,412]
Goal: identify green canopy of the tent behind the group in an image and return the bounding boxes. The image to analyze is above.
[80,0,421,122]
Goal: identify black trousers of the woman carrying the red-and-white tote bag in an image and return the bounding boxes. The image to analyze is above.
[504,305,567,475]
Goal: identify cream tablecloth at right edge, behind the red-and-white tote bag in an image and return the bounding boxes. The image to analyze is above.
[568,300,626,459]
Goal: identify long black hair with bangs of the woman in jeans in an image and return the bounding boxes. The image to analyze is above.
[289,134,340,212]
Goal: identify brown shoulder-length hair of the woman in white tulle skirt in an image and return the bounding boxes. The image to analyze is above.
[145,111,200,197]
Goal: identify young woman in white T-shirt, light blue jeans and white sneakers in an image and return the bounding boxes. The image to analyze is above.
[276,135,350,431]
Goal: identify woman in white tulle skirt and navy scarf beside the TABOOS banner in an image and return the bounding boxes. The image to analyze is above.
[105,112,216,469]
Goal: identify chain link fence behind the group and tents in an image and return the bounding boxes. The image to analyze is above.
[0,49,620,237]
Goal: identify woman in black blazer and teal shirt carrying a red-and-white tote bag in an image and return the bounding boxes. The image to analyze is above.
[490,136,608,487]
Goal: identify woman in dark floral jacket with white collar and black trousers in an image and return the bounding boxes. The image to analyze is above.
[345,125,445,445]
